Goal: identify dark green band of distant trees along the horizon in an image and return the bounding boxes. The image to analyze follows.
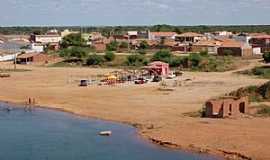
[0,24,270,36]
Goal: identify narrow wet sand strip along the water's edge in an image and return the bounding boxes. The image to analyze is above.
[0,99,252,160]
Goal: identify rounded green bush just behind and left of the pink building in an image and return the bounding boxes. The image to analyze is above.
[125,54,148,66]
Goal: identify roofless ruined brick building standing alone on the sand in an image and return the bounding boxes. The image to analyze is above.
[205,97,249,118]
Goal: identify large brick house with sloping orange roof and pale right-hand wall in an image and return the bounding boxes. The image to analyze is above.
[217,39,253,57]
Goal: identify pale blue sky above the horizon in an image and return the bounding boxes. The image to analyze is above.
[0,0,270,26]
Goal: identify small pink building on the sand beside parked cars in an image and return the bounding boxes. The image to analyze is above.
[144,61,170,76]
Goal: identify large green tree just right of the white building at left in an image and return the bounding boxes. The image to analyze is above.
[60,33,86,48]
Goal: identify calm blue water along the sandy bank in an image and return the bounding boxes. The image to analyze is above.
[0,103,221,160]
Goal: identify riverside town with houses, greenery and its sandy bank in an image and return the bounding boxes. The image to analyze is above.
[0,28,270,160]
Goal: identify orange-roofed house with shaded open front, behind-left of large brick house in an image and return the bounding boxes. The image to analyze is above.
[175,32,206,44]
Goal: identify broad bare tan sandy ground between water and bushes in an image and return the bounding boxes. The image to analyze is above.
[0,60,270,160]
